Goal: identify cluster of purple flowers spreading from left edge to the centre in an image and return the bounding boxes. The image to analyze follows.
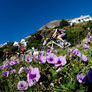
[0,50,67,90]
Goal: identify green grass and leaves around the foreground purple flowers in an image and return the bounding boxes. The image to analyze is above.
[0,21,92,92]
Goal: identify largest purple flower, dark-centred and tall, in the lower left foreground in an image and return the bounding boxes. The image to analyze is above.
[27,68,40,87]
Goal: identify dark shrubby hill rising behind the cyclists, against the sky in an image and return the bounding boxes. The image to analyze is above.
[0,16,92,59]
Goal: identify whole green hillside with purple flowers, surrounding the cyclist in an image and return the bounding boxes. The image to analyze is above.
[0,20,92,92]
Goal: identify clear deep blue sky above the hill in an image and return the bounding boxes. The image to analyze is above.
[0,0,92,44]
